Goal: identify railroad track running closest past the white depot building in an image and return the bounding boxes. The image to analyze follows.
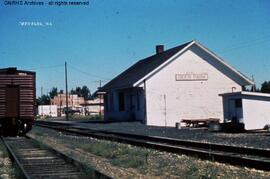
[35,121,270,171]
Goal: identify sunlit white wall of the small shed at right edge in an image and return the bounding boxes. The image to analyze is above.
[243,97,270,130]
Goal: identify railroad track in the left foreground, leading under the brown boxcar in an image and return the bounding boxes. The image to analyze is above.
[1,137,109,179]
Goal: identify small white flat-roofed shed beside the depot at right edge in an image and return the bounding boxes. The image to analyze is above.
[220,91,270,130]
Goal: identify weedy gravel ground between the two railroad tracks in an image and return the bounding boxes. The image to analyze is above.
[29,127,270,179]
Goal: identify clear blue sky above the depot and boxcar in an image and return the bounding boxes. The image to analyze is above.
[0,0,270,94]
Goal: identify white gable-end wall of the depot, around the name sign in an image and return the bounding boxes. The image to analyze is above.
[144,48,242,126]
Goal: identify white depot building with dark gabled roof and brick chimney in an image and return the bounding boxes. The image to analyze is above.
[99,41,253,126]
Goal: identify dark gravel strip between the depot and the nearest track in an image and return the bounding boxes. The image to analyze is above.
[65,122,270,150]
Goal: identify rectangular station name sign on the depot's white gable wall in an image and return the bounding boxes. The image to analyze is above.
[175,73,208,81]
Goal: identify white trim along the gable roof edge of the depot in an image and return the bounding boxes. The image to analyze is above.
[133,40,254,87]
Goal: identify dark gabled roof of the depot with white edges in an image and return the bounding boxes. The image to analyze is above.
[98,40,254,92]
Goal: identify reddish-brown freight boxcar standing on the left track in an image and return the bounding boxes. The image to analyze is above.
[0,68,36,135]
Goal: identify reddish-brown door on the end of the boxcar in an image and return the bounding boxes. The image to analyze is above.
[6,86,19,118]
